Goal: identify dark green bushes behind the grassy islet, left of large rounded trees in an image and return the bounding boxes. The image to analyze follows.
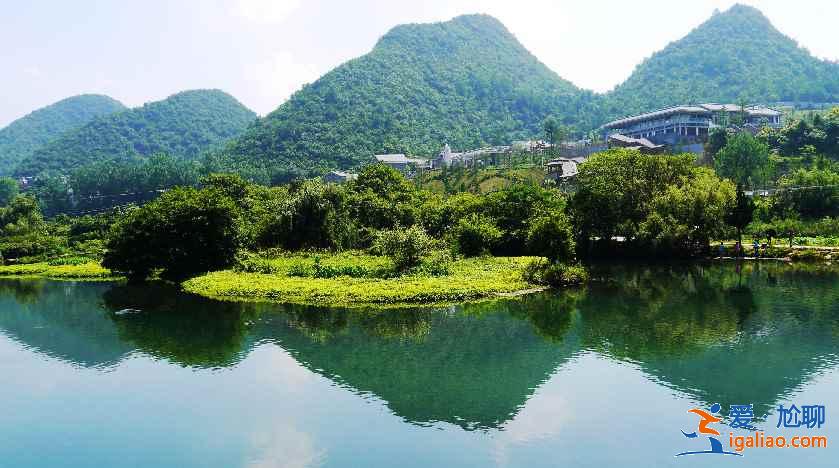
[98,165,574,277]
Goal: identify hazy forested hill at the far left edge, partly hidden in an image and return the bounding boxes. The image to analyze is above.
[0,94,125,176]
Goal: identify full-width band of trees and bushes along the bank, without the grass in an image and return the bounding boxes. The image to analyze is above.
[0,145,839,277]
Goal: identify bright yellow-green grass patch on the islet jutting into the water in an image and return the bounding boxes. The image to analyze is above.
[183,252,534,306]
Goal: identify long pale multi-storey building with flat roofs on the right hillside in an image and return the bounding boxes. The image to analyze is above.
[603,104,783,152]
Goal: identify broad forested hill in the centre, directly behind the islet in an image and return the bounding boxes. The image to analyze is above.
[221,15,595,179]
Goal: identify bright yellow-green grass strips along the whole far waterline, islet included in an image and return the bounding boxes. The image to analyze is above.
[0,248,833,308]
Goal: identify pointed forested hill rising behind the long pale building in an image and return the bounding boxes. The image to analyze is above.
[604,5,839,116]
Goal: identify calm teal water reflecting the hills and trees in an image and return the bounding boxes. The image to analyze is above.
[0,264,839,468]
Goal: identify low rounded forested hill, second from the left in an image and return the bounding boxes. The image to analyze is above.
[15,90,256,175]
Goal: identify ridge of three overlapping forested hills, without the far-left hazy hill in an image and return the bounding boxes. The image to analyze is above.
[8,5,839,178]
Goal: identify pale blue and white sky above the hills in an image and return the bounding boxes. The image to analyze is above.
[0,0,839,126]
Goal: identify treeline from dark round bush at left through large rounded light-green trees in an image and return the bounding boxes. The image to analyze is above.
[8,150,750,277]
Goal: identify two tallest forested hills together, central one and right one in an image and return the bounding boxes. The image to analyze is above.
[218,5,839,173]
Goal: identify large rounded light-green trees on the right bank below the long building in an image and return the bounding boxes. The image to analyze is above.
[570,149,740,256]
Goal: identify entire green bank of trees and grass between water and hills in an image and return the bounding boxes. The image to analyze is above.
[0,142,839,307]
